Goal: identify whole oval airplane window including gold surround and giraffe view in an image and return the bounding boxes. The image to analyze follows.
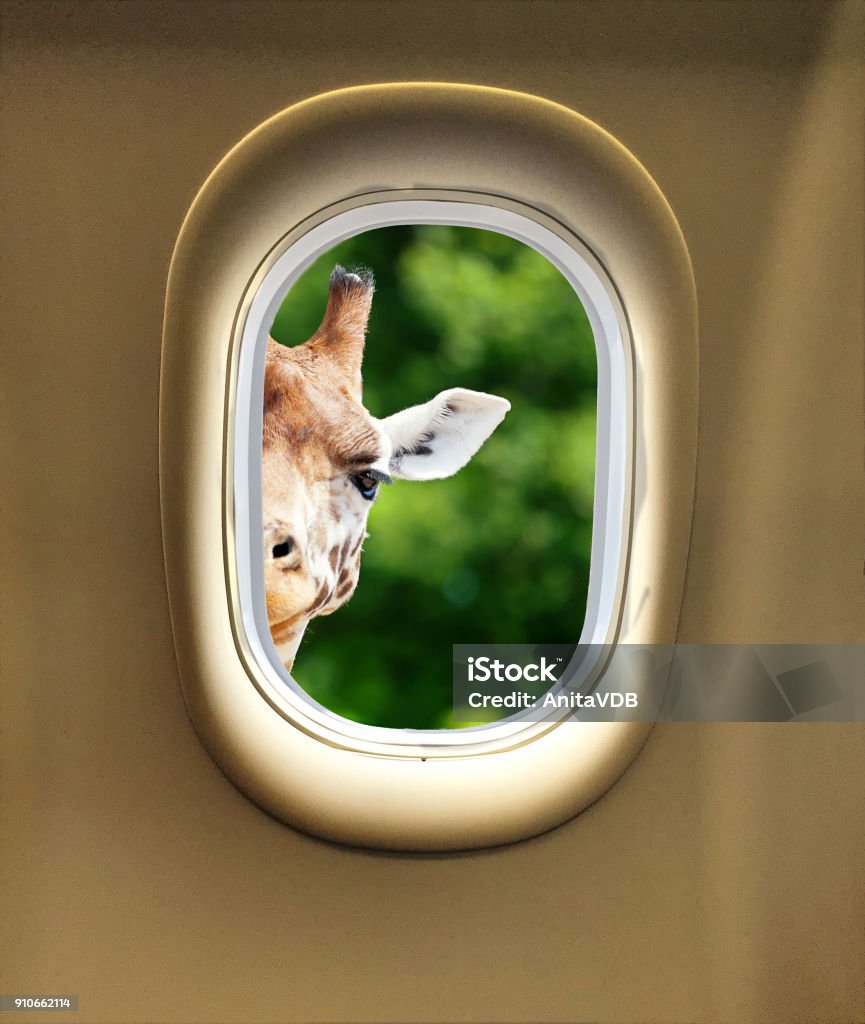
[160,83,698,851]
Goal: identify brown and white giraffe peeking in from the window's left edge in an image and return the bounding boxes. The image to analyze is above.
[262,264,511,672]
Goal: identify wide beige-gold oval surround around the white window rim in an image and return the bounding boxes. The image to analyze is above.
[160,84,697,850]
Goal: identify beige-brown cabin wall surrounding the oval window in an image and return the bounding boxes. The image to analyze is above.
[0,0,865,1024]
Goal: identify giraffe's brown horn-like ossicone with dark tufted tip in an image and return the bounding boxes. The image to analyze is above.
[307,263,376,399]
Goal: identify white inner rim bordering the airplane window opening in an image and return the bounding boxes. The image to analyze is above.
[227,191,634,758]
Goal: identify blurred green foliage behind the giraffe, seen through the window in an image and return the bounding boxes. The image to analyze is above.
[272,225,597,729]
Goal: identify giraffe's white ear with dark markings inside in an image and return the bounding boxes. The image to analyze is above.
[381,388,511,480]
